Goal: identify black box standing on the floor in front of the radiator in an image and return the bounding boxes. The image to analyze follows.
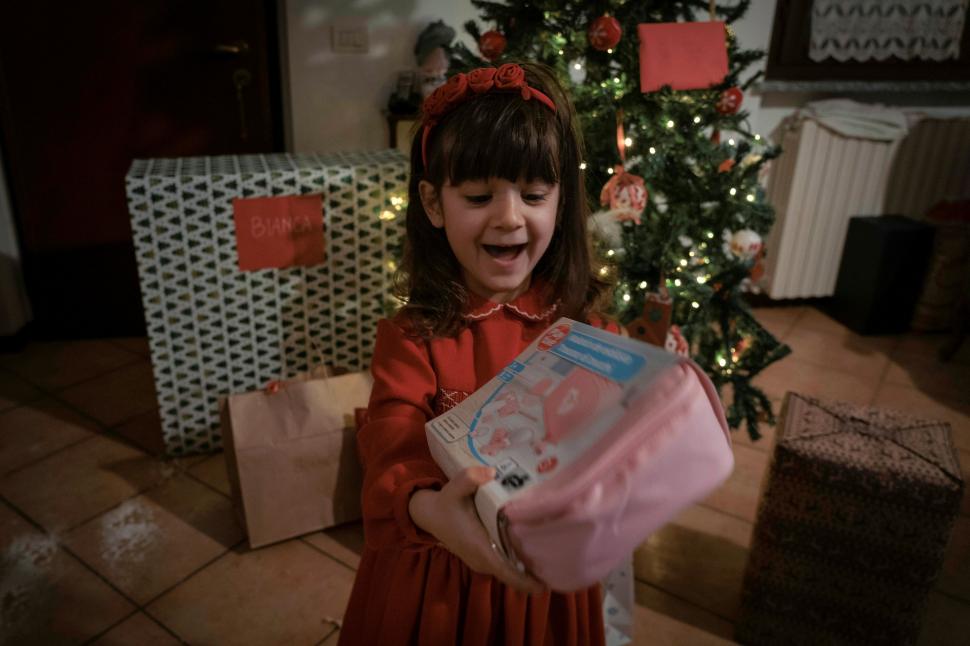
[828,215,935,334]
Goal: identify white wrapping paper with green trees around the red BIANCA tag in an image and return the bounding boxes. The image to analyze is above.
[126,150,408,455]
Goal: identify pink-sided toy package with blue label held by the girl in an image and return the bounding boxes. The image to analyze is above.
[425,318,734,591]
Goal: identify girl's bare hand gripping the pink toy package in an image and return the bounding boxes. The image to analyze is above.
[408,467,546,594]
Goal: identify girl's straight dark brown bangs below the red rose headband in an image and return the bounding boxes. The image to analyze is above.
[438,94,560,185]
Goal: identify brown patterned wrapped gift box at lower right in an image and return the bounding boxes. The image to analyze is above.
[735,393,964,646]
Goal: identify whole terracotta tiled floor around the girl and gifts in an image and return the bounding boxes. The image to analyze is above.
[0,307,970,646]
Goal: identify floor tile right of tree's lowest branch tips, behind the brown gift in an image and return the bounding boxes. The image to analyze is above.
[754,357,879,404]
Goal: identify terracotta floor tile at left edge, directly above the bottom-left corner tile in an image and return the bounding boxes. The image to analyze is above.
[0,435,178,532]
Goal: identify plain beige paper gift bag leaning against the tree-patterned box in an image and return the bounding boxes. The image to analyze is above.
[221,372,372,548]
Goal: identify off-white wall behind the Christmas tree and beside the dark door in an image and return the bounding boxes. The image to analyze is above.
[285,0,970,152]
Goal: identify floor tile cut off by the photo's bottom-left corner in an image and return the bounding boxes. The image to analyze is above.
[0,502,135,645]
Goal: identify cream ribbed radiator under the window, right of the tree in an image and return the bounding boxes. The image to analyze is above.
[762,116,970,299]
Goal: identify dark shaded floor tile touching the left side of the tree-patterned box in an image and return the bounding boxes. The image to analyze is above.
[57,360,158,426]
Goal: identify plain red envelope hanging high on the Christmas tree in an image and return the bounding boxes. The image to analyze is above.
[637,22,728,93]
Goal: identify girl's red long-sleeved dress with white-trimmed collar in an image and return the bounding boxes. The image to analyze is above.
[339,288,604,646]
